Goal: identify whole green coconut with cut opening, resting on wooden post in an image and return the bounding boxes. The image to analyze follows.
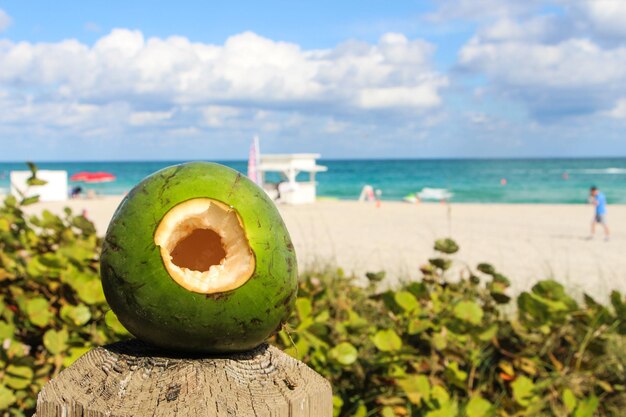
[100,162,297,353]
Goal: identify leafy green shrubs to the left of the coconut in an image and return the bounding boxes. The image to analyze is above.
[0,193,127,416]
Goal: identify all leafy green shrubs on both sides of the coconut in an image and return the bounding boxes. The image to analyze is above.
[0,171,626,417]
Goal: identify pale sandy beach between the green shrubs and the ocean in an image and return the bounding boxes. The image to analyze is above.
[28,197,626,300]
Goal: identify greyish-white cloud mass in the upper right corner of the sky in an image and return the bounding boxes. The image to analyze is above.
[458,0,626,121]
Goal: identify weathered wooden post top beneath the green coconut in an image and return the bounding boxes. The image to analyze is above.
[36,340,332,417]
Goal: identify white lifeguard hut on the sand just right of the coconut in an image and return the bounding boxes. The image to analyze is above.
[257,153,327,204]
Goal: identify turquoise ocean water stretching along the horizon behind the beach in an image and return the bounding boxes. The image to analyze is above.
[0,158,626,204]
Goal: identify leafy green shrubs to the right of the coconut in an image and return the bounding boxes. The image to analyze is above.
[274,239,626,417]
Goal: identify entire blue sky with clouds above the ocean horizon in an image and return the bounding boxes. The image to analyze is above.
[0,0,626,161]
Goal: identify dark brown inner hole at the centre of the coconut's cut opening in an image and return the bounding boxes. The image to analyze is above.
[171,229,226,272]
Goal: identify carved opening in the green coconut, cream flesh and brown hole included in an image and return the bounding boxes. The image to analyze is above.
[154,198,255,294]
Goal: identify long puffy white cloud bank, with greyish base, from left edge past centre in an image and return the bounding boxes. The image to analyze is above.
[0,29,447,143]
